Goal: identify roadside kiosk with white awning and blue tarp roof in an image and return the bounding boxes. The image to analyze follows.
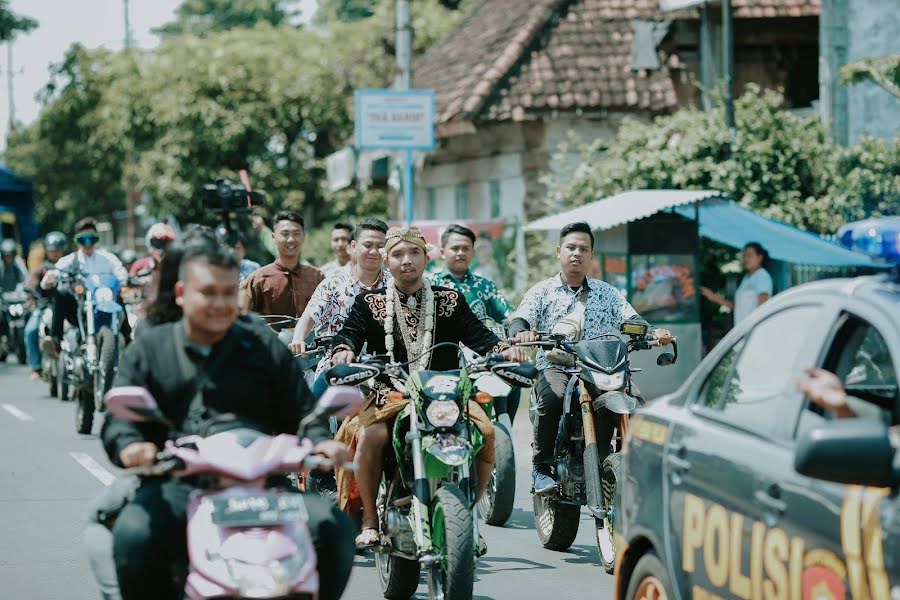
[525,190,880,399]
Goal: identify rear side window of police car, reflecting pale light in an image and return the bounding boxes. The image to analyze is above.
[696,305,821,435]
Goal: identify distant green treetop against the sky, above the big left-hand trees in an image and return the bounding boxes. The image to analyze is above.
[154,0,299,37]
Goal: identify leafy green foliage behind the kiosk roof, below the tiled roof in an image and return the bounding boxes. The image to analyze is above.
[545,88,900,232]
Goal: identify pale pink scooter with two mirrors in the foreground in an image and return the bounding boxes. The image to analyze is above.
[106,387,363,600]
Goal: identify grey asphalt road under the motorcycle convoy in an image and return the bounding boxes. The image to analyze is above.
[0,362,612,600]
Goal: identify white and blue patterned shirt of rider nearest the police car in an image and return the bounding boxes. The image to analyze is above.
[512,275,638,370]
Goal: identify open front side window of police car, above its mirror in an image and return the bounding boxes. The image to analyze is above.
[797,315,900,436]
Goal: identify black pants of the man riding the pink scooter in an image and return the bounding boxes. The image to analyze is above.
[113,479,356,600]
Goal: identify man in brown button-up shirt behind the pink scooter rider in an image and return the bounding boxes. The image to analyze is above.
[240,210,325,331]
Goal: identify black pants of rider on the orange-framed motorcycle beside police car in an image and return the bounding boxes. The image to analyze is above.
[532,367,618,465]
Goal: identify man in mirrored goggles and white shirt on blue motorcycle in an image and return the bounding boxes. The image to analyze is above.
[41,217,130,357]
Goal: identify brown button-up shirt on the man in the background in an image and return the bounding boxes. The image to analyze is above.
[241,259,325,330]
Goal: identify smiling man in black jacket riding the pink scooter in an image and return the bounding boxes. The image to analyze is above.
[101,241,353,600]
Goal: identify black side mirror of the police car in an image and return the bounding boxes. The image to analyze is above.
[794,419,900,487]
